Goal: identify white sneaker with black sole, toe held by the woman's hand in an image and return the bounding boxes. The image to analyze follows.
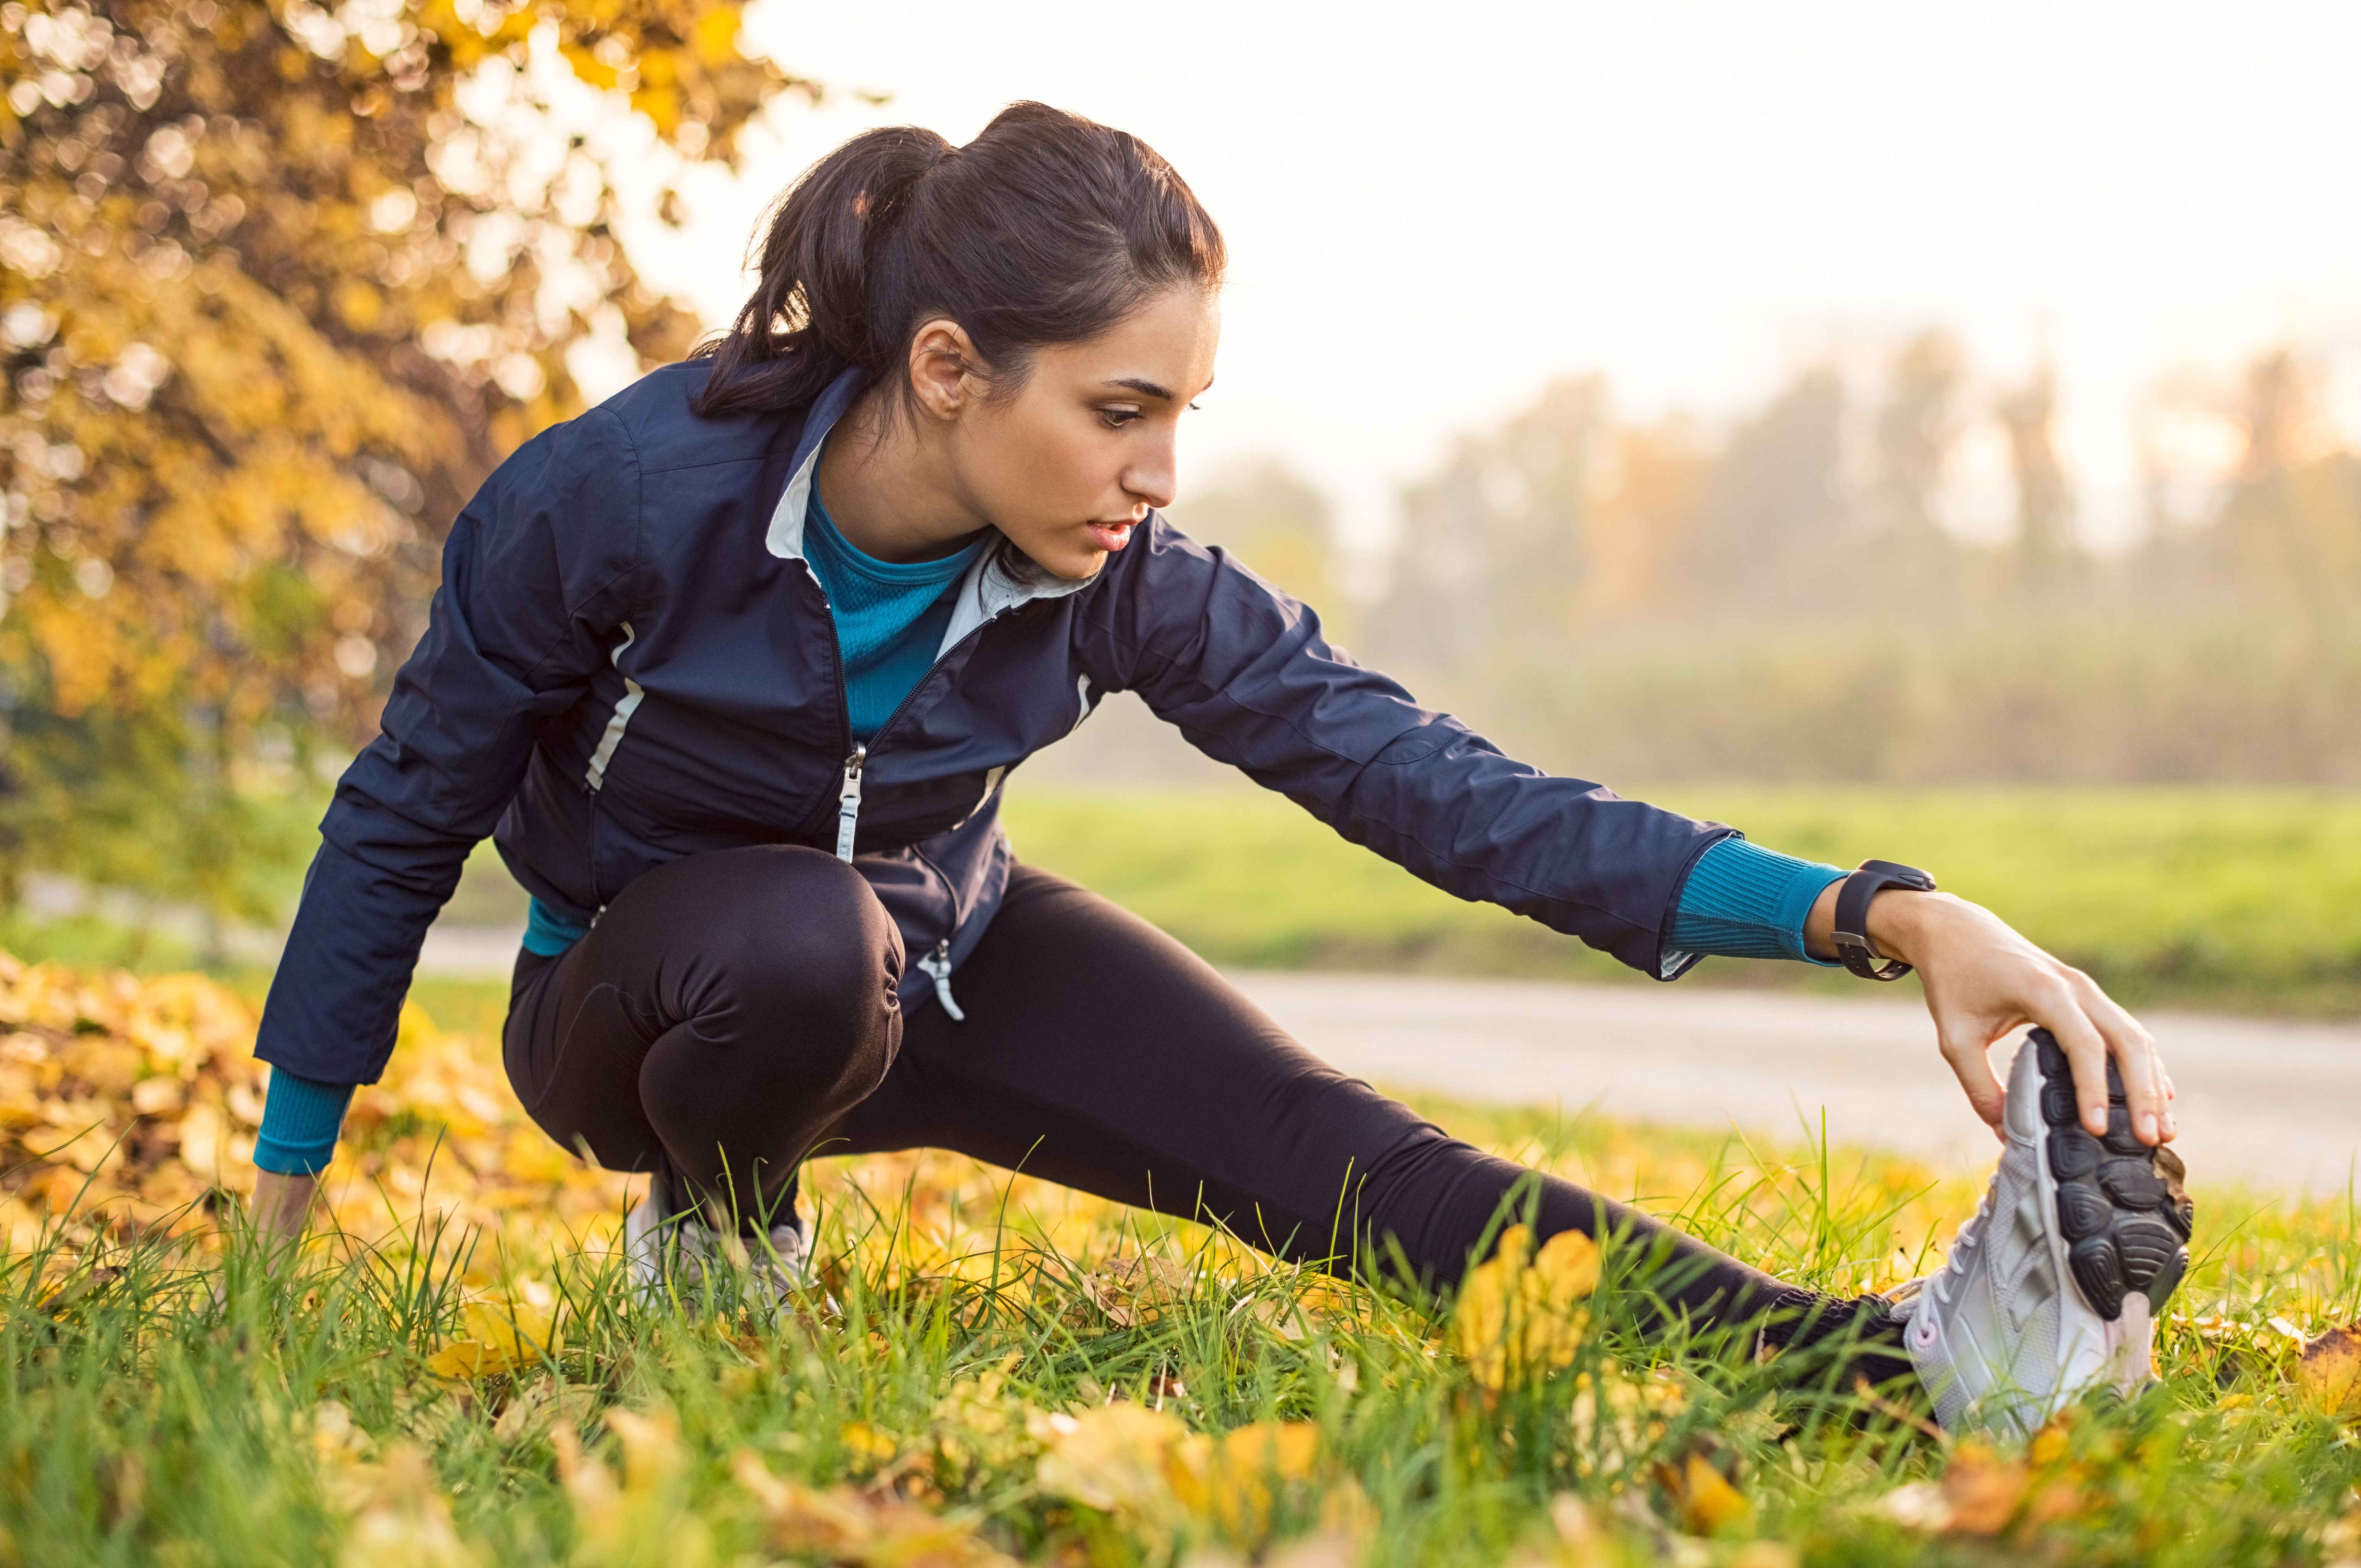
[1896,1030,2193,1436]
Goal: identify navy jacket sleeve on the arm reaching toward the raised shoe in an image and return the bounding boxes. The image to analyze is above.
[1077,517,1731,980]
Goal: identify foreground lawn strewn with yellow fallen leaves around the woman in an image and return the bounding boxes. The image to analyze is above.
[0,961,2361,1568]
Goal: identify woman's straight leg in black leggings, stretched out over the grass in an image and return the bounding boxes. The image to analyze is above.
[815,867,1818,1325]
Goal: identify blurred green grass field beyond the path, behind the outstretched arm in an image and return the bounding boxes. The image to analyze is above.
[1006,782,2361,1018]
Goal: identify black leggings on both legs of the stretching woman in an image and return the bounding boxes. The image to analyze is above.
[505,848,1898,1369]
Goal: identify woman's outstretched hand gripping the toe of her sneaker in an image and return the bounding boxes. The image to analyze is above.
[1804,883,2179,1143]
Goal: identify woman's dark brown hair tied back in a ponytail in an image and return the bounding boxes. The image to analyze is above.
[692,104,1228,418]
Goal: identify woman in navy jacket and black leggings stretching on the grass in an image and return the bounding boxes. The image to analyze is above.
[255,104,2186,1422]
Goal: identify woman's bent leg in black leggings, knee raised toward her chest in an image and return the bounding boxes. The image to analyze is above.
[503,845,902,1230]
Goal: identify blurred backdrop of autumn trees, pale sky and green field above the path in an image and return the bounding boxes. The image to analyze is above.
[0,0,2361,1018]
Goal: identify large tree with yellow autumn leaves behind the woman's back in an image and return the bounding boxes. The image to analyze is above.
[0,0,812,944]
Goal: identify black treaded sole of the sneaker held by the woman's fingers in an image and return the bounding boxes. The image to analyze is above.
[2031,1030,2196,1322]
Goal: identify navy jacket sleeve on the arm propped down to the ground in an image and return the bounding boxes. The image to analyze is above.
[255,409,640,1084]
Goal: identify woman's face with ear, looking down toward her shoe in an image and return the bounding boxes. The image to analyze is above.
[949,286,1220,578]
